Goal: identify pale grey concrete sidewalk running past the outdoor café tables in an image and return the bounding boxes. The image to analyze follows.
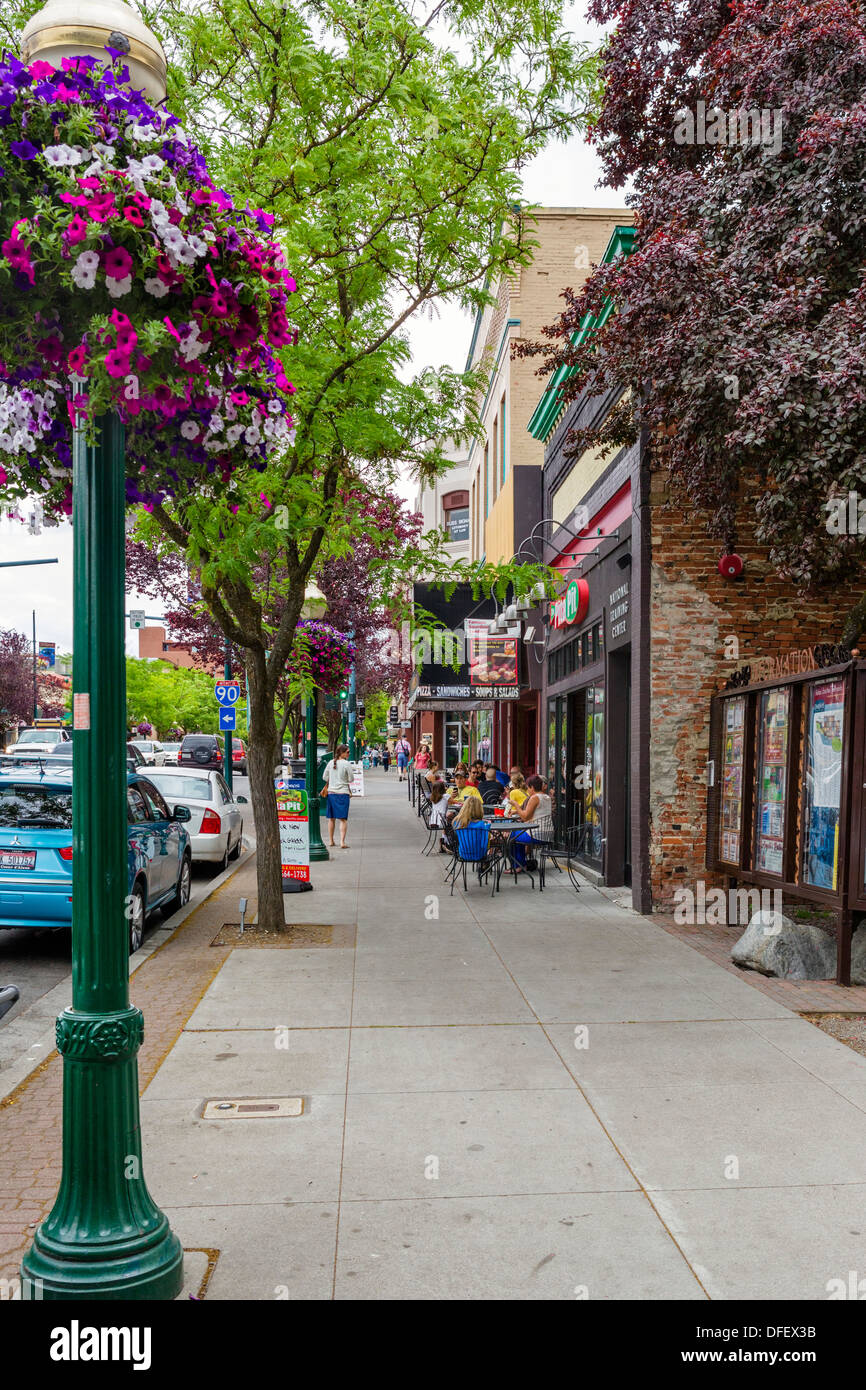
[142,771,866,1300]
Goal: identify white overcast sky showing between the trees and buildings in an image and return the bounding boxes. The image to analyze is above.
[0,3,624,656]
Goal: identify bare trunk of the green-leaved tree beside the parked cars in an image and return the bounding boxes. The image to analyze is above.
[246,648,285,931]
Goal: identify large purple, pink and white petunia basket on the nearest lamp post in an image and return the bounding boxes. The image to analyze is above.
[0,53,296,512]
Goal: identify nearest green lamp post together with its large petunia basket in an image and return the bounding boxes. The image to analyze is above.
[0,0,295,1300]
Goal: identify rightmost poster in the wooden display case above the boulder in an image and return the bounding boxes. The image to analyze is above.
[802,681,845,891]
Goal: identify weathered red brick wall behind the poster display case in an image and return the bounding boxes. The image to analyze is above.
[649,470,852,909]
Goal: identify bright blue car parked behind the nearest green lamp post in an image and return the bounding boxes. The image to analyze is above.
[0,759,192,952]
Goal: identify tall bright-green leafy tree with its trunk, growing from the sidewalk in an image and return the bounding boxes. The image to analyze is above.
[6,0,578,930]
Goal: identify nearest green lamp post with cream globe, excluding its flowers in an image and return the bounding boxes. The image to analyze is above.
[21,0,183,1300]
